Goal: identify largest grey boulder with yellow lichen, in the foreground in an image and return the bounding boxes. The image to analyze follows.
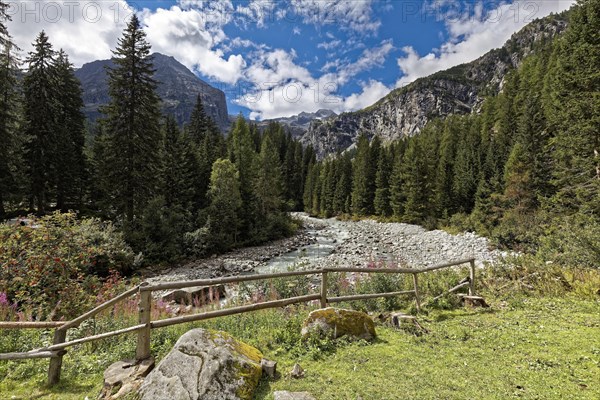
[139,329,262,400]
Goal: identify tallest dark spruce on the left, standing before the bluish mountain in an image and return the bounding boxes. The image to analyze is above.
[103,15,160,222]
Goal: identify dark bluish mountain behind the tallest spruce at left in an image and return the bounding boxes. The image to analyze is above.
[75,53,229,130]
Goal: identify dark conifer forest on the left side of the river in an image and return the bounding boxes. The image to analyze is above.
[0,9,314,262]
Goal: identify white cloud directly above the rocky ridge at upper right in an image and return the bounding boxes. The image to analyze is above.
[396,0,574,87]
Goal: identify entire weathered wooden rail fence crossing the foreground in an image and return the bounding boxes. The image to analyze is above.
[0,258,475,385]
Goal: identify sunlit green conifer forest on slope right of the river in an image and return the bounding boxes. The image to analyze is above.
[304,0,600,261]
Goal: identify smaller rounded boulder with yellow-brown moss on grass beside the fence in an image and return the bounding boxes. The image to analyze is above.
[302,307,377,340]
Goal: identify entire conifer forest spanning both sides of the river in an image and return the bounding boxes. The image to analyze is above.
[0,0,600,268]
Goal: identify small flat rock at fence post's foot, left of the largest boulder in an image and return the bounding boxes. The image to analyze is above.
[98,357,154,400]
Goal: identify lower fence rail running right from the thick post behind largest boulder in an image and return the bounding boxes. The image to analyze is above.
[151,293,321,328]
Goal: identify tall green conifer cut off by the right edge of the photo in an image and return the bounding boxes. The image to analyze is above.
[548,0,600,218]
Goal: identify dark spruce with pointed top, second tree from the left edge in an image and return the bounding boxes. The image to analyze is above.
[23,31,59,213]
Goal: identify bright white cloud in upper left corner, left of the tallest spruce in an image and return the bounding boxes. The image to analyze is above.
[7,0,133,66]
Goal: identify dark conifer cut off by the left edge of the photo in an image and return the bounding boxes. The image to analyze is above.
[0,1,23,216]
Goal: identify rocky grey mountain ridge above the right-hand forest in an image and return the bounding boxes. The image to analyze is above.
[301,12,568,157]
